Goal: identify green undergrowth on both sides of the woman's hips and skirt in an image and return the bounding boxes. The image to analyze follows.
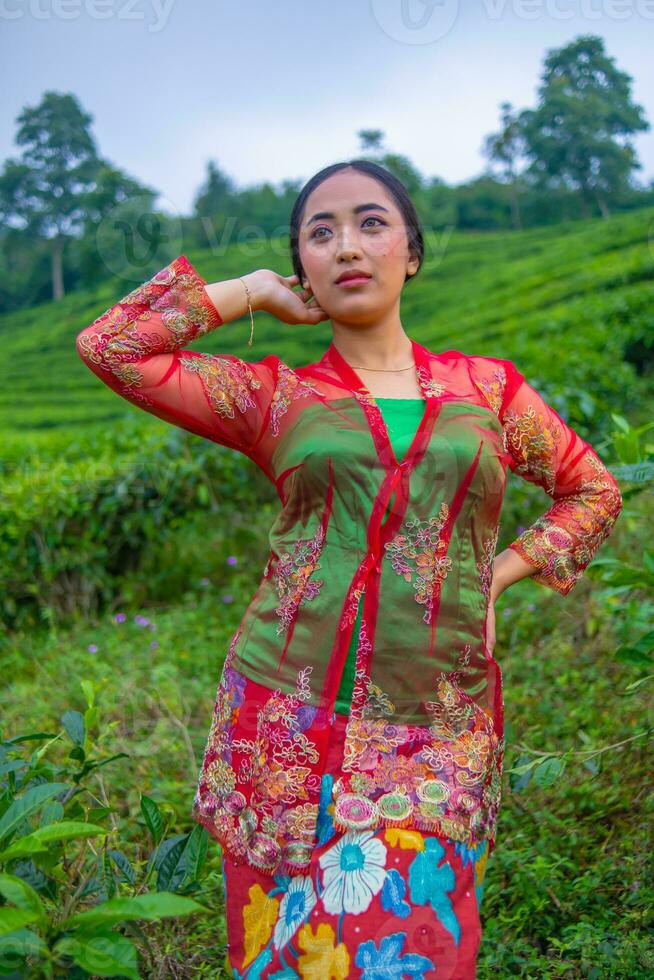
[0,423,654,980]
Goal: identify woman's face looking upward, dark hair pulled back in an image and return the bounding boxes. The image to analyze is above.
[299,170,419,324]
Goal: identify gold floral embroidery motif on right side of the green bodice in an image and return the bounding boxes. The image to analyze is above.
[384,501,452,623]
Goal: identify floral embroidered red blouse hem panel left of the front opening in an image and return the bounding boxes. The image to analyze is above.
[192,668,320,874]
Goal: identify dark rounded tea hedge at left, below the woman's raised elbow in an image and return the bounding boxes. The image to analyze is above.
[0,419,277,628]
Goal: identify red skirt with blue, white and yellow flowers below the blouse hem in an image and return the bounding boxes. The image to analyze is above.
[223,776,488,980]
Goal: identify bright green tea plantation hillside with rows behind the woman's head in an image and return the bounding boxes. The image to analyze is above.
[0,208,654,454]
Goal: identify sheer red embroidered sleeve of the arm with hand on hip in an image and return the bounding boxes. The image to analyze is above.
[499,361,622,595]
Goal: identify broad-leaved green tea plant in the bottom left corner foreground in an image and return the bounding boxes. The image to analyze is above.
[0,682,215,980]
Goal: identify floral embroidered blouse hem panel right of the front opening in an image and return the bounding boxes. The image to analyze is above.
[333,644,504,840]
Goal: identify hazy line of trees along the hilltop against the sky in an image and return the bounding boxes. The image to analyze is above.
[0,35,654,313]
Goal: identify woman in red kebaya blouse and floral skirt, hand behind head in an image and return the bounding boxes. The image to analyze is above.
[77,160,622,980]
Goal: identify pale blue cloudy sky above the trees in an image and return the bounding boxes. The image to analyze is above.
[0,0,654,214]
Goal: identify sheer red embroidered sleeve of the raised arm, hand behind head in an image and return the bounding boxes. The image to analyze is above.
[77,255,275,464]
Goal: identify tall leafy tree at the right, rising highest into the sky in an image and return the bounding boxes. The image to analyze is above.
[519,35,650,217]
